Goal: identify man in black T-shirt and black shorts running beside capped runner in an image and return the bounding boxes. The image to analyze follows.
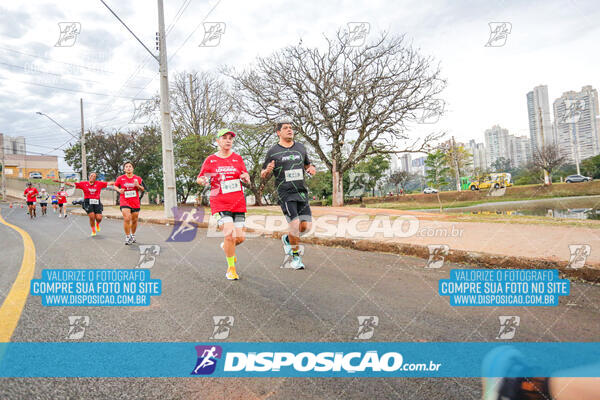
[260,122,316,269]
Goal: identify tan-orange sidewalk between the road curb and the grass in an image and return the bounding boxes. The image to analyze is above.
[71,206,600,279]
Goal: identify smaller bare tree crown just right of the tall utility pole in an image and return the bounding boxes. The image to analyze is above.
[171,71,233,136]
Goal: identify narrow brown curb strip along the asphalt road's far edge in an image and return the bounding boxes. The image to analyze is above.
[71,210,600,283]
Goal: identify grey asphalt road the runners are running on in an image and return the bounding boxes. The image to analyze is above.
[0,205,600,400]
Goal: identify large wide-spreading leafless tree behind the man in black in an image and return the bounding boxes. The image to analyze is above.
[223,31,446,205]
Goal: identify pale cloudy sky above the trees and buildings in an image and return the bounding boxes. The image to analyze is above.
[0,0,600,171]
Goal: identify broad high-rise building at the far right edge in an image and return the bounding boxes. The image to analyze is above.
[553,85,600,163]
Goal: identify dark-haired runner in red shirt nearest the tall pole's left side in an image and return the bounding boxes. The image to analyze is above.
[115,161,145,245]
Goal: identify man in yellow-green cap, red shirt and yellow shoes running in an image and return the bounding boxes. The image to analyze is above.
[196,129,250,280]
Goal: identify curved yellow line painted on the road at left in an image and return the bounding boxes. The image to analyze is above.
[0,208,35,343]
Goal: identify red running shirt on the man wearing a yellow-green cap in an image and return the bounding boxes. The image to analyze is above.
[198,153,248,214]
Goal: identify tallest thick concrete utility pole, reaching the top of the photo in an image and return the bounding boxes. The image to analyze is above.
[157,0,177,218]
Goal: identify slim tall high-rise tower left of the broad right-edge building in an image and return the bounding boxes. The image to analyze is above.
[527,85,556,151]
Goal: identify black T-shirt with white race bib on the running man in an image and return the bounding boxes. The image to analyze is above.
[263,142,310,202]
